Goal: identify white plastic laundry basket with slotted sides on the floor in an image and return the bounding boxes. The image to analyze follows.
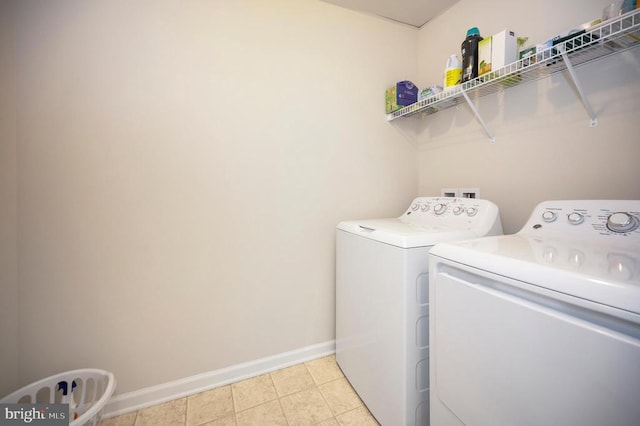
[0,368,116,426]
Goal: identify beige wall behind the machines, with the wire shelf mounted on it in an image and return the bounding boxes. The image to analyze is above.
[416,0,640,233]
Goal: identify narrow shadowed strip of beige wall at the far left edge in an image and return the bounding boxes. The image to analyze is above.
[0,2,19,396]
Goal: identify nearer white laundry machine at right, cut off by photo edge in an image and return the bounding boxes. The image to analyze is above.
[430,200,640,426]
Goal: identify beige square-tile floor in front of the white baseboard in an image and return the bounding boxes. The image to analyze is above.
[100,356,378,426]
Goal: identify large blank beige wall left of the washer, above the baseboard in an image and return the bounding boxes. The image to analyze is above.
[15,0,418,393]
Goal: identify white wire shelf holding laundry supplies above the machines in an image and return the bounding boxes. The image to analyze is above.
[387,9,640,121]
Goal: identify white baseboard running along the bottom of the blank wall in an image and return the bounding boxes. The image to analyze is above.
[102,340,336,419]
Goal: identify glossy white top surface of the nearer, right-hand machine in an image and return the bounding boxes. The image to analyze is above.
[431,234,640,314]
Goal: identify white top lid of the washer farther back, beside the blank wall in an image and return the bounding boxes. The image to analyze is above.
[338,218,478,248]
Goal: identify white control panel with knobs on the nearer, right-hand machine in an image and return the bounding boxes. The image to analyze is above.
[522,200,640,238]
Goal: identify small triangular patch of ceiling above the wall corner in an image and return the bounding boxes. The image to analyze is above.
[323,0,458,28]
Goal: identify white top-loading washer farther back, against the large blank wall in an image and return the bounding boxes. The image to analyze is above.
[336,197,502,426]
